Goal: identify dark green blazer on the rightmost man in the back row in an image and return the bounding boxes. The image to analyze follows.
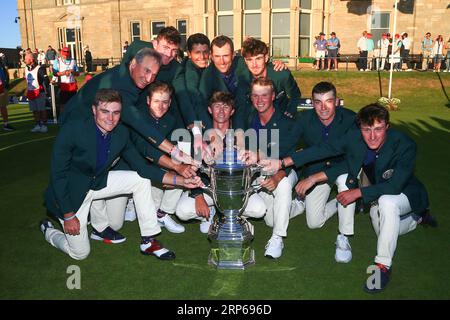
[233,62,301,129]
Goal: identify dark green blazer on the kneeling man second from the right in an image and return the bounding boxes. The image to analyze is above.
[293,107,356,185]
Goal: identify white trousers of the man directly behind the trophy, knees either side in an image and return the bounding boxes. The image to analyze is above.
[176,191,266,221]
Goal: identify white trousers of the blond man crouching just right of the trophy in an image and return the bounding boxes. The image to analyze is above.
[258,170,298,237]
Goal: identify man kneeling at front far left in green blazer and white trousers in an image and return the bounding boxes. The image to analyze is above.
[40,89,202,260]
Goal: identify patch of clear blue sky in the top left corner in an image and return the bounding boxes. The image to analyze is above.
[0,0,21,48]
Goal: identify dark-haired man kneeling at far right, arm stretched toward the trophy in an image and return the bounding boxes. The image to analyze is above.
[263,104,437,293]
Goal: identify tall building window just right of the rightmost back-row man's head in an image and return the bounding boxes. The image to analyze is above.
[271,7,290,57]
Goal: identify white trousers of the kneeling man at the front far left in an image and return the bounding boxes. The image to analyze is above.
[45,171,161,260]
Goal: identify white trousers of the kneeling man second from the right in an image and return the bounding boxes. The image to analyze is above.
[305,174,355,236]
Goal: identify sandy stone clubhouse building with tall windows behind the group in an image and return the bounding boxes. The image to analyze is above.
[16,0,450,65]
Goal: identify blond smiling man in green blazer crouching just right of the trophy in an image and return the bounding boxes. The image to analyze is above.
[248,78,297,259]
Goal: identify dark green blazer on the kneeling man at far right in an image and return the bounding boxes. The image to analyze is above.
[292,128,429,215]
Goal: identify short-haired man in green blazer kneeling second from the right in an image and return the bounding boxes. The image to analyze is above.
[291,82,355,263]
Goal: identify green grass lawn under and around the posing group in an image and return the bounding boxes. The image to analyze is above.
[0,71,450,300]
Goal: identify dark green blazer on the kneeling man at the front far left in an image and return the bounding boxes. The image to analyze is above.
[44,117,165,218]
